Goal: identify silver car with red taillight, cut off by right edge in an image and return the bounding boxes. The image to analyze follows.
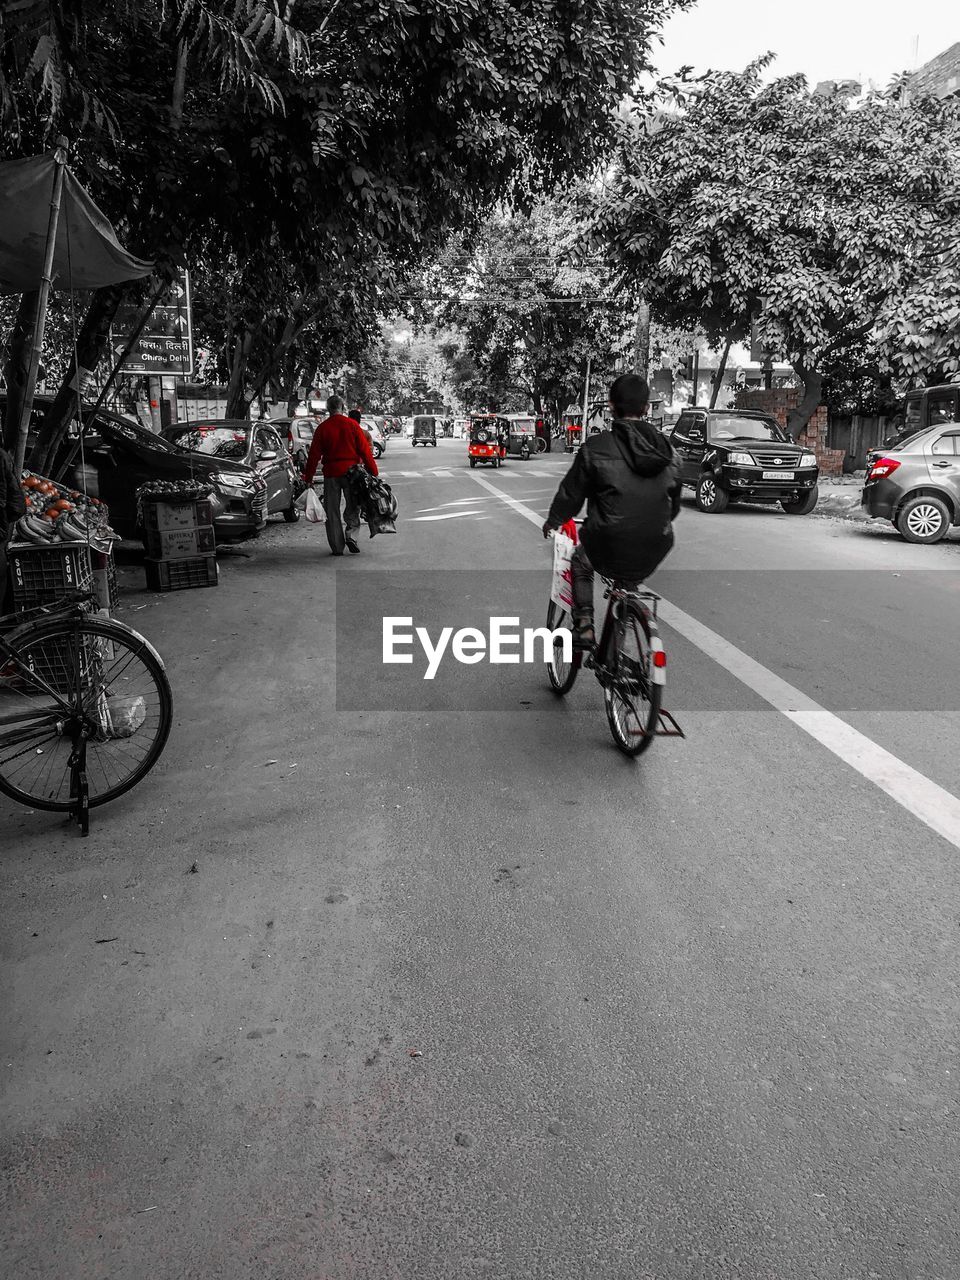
[861,421,960,543]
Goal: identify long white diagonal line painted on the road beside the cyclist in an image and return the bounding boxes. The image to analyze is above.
[471,475,960,849]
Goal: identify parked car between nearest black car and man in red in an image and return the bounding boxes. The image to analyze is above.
[161,419,303,525]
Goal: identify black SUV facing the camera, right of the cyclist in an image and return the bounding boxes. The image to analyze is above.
[668,408,819,516]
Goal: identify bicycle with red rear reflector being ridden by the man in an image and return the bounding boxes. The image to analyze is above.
[547,550,686,756]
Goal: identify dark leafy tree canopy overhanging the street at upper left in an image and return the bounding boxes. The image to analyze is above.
[0,0,682,465]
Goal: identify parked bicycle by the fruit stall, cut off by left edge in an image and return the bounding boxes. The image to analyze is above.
[0,591,173,836]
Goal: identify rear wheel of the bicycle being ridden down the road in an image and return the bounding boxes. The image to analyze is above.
[603,600,663,756]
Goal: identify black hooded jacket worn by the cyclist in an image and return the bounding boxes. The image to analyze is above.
[548,419,681,579]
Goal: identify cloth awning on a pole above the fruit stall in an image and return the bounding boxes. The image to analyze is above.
[0,152,154,293]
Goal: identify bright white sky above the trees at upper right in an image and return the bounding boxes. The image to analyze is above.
[653,0,960,88]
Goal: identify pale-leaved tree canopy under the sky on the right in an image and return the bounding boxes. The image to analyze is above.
[593,59,960,434]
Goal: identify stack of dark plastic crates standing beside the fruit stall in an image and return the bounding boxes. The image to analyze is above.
[141,494,219,591]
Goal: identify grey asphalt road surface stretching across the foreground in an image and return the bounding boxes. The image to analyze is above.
[0,440,960,1280]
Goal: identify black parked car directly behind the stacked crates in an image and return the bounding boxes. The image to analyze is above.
[0,396,266,543]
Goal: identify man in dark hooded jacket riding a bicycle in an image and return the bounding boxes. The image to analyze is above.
[543,374,681,652]
